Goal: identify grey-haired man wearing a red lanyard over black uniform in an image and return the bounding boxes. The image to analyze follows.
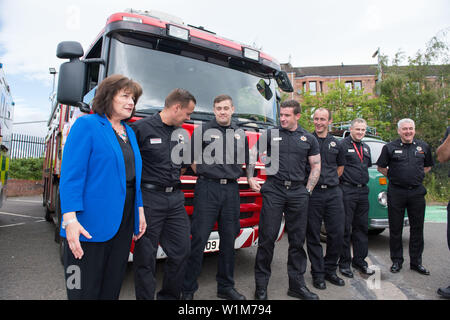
[339,118,375,278]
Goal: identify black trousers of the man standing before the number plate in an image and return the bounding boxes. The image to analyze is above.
[183,179,240,293]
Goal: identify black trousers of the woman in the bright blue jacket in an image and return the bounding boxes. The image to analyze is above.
[63,188,135,300]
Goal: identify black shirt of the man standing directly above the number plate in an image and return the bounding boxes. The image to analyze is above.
[191,118,249,179]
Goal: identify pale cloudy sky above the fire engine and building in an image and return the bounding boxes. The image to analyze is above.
[0,0,450,136]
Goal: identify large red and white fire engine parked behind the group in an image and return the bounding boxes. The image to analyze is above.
[43,9,293,258]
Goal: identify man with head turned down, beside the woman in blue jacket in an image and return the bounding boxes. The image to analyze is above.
[132,89,196,300]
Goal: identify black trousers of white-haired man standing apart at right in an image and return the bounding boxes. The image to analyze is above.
[388,184,427,265]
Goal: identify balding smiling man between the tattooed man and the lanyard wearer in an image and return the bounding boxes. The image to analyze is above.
[306,108,345,290]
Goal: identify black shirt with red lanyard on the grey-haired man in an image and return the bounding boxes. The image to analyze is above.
[340,135,372,185]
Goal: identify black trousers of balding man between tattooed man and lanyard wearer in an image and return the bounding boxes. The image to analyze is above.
[306,186,345,280]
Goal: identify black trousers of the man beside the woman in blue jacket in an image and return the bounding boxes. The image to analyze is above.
[133,186,190,300]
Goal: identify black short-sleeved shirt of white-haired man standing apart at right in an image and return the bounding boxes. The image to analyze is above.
[377,139,434,187]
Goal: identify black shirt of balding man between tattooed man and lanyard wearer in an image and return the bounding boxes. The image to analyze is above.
[307,132,345,187]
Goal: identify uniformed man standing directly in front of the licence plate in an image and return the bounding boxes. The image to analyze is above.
[183,95,255,300]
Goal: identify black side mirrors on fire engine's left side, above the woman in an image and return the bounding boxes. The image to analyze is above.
[56,41,87,106]
